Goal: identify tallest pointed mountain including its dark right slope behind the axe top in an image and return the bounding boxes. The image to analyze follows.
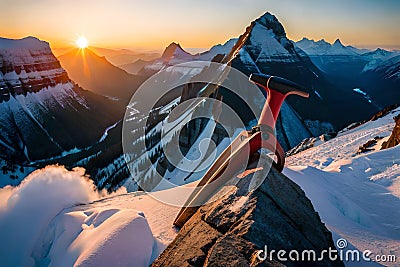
[232,13,377,132]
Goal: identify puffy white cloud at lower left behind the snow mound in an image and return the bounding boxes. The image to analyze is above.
[0,166,126,266]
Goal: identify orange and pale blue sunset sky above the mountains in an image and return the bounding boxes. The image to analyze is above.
[0,0,400,49]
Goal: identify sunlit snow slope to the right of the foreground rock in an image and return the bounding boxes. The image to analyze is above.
[284,108,400,266]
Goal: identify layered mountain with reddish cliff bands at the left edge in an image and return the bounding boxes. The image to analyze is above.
[0,37,121,162]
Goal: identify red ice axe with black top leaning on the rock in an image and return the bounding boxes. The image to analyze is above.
[174,74,309,227]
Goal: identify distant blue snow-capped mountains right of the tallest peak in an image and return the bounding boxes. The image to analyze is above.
[296,38,400,110]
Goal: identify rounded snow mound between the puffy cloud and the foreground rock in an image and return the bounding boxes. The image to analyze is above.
[35,192,179,266]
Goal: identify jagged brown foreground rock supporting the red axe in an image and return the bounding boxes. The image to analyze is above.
[152,164,343,267]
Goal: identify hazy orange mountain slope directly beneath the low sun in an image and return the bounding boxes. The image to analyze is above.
[58,48,145,101]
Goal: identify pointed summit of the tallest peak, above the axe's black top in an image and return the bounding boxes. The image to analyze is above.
[233,13,320,87]
